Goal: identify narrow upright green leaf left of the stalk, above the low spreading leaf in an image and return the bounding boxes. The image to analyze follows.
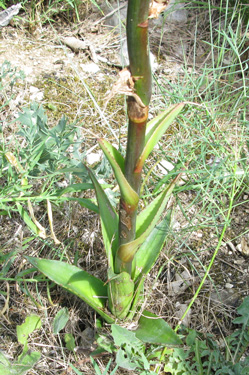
[88,169,118,270]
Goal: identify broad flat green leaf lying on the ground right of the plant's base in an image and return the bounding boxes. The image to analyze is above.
[134,311,182,346]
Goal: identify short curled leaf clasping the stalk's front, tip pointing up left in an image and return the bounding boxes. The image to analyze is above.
[99,139,139,207]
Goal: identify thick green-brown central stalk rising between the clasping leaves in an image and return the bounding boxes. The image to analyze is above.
[116,0,151,273]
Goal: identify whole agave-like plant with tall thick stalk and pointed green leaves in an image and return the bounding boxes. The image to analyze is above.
[26,0,184,344]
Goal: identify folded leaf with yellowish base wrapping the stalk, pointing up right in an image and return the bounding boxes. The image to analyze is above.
[118,175,180,261]
